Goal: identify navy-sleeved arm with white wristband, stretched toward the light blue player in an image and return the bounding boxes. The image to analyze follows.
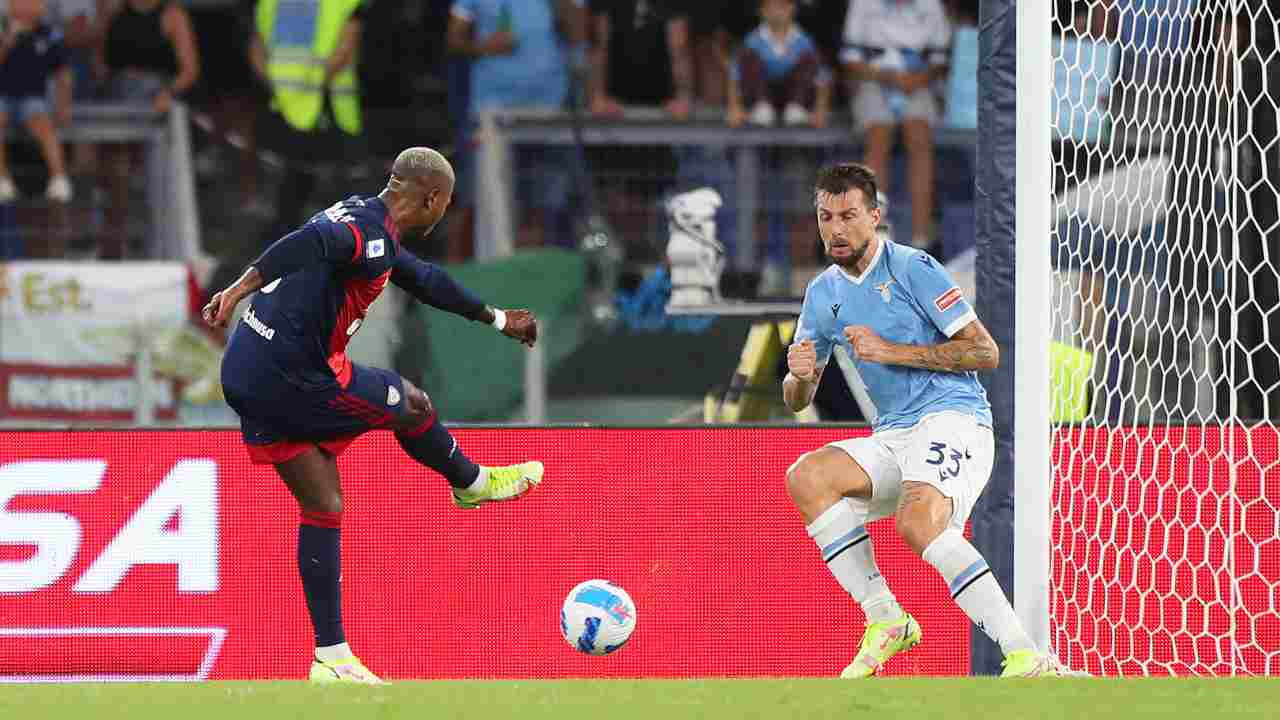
[392,249,538,346]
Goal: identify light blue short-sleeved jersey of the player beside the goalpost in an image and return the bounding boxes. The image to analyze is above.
[796,240,991,430]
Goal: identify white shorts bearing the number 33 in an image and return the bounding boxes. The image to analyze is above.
[828,411,996,532]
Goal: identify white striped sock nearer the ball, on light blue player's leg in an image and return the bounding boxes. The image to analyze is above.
[808,500,902,624]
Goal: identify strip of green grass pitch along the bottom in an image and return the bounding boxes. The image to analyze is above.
[0,678,1280,720]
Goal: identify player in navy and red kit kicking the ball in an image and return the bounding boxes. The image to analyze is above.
[204,147,543,683]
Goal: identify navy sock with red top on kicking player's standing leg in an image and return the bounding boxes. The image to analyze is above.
[298,511,347,647]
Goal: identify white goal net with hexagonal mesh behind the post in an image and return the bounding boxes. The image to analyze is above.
[1050,0,1280,675]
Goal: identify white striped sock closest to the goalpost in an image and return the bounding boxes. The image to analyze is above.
[924,528,1036,655]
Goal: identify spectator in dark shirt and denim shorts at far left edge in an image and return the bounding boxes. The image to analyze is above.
[0,0,72,202]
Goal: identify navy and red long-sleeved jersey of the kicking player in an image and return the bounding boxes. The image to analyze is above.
[224,196,485,388]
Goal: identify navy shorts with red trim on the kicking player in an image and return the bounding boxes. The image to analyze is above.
[223,364,419,465]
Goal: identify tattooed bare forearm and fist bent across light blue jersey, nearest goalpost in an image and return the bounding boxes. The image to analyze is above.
[845,319,1000,373]
